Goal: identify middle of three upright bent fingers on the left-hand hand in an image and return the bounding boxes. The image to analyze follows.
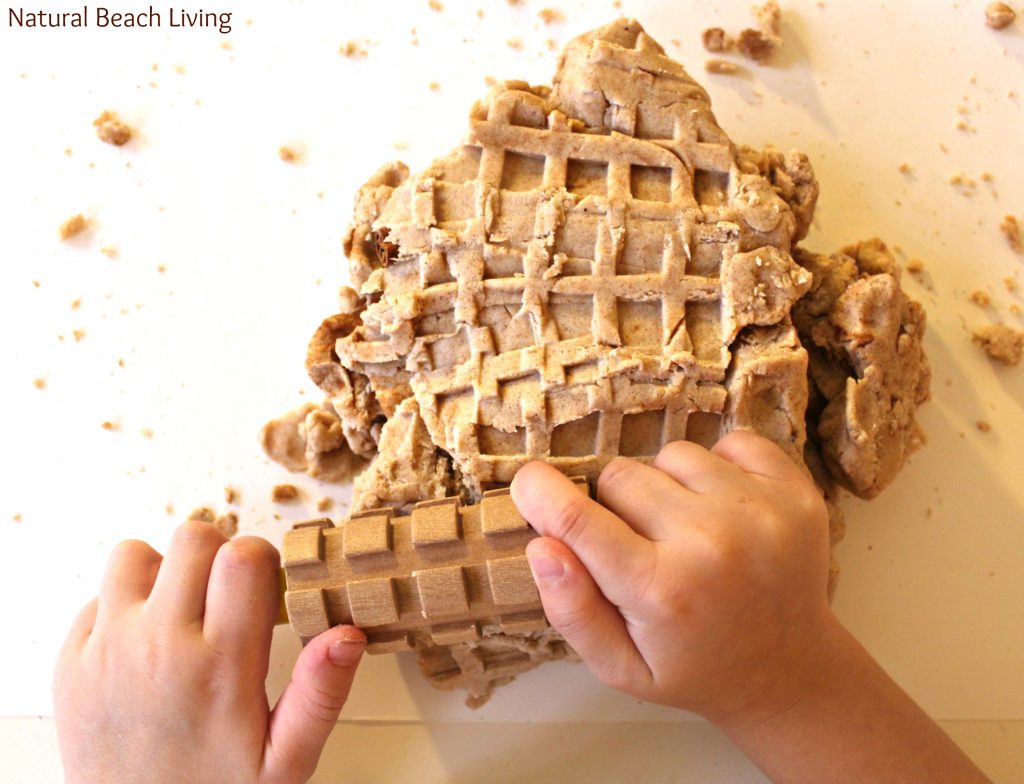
[147,520,227,623]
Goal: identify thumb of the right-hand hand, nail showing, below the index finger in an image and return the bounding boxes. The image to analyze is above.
[526,536,651,690]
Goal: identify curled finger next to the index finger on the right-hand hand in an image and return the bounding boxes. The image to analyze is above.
[597,458,701,541]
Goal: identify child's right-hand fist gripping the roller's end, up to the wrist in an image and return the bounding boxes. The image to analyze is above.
[512,431,835,721]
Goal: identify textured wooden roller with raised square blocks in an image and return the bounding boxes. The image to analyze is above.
[282,478,587,653]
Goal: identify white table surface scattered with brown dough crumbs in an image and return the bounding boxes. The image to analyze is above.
[0,0,1024,781]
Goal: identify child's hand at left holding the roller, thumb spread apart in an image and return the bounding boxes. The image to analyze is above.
[54,522,366,784]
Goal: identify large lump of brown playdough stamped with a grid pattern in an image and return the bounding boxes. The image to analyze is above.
[263,19,929,703]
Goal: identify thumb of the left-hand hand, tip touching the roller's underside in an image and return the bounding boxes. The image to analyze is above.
[261,626,367,782]
